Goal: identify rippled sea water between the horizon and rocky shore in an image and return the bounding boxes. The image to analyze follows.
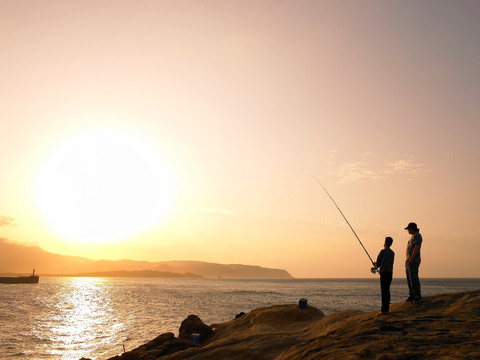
[0,277,480,360]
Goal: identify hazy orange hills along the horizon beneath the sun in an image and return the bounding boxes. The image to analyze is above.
[0,238,292,279]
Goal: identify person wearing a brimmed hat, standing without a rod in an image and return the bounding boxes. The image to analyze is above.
[405,223,422,304]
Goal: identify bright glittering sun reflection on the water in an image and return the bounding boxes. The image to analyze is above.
[31,278,126,360]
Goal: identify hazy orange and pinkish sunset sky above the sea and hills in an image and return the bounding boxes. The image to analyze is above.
[0,0,480,277]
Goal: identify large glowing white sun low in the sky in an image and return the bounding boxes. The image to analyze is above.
[34,129,175,242]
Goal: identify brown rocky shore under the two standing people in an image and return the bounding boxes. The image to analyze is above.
[83,290,480,360]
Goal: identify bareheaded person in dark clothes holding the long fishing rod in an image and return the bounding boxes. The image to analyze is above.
[372,236,395,315]
